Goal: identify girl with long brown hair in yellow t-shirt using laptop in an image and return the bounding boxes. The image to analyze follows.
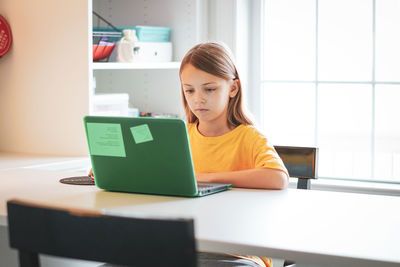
[180,42,288,189]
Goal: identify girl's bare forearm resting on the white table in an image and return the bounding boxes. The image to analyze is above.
[196,168,289,189]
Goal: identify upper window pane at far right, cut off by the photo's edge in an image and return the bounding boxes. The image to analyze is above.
[375,0,400,81]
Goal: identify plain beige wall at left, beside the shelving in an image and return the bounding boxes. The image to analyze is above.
[0,0,89,155]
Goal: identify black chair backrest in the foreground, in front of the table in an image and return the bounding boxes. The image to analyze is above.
[7,200,197,267]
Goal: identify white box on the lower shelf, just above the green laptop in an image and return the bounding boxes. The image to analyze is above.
[93,94,129,116]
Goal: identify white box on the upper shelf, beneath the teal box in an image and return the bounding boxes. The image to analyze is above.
[133,42,172,62]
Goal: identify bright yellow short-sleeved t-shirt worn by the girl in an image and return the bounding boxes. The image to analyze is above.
[188,123,288,177]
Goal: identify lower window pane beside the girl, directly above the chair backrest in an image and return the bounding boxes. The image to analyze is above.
[262,83,315,146]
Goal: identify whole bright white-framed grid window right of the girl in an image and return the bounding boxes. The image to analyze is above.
[259,0,400,183]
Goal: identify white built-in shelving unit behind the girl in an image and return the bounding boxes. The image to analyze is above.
[89,0,207,116]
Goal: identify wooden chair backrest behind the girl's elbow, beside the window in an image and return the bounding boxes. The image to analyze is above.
[275,146,318,189]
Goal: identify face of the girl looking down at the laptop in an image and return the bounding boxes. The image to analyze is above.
[181,64,237,123]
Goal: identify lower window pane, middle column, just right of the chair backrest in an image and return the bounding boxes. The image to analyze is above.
[318,84,372,178]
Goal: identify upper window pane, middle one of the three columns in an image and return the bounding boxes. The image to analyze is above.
[318,0,372,81]
